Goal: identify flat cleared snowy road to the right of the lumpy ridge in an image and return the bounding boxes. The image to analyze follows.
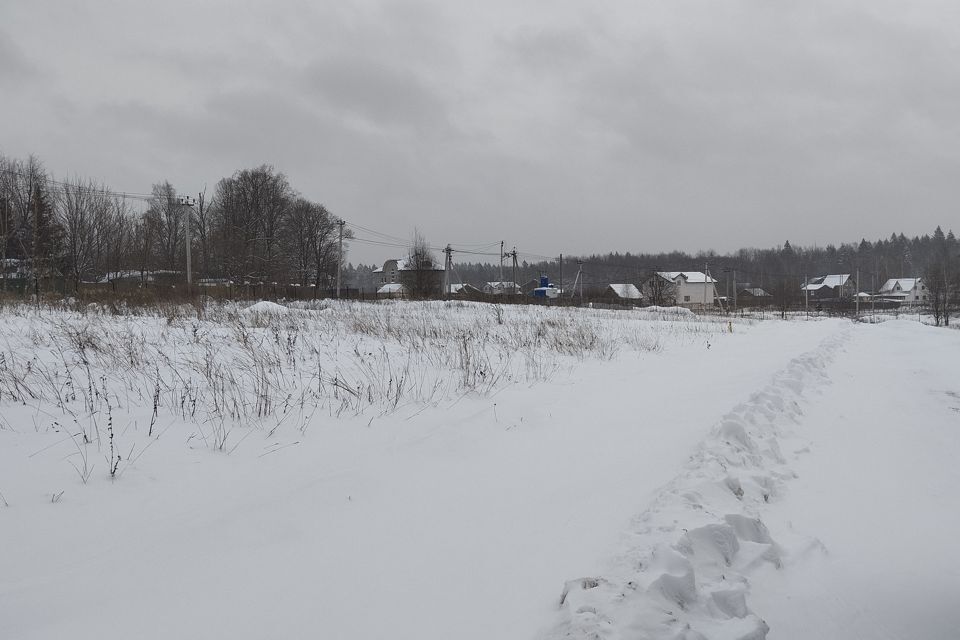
[751,321,960,640]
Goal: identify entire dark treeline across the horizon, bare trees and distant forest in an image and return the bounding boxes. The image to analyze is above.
[0,156,960,304]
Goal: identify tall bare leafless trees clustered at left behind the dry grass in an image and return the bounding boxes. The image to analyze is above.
[0,156,350,287]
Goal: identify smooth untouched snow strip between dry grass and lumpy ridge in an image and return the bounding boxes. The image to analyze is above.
[0,321,848,639]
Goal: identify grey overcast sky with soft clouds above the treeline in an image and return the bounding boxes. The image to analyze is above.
[0,0,960,262]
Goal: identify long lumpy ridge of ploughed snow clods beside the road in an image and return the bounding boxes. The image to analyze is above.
[547,327,850,640]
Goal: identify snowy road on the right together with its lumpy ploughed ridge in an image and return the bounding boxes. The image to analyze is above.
[547,321,960,640]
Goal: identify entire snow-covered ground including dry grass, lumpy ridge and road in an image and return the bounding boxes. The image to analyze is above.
[0,303,960,639]
